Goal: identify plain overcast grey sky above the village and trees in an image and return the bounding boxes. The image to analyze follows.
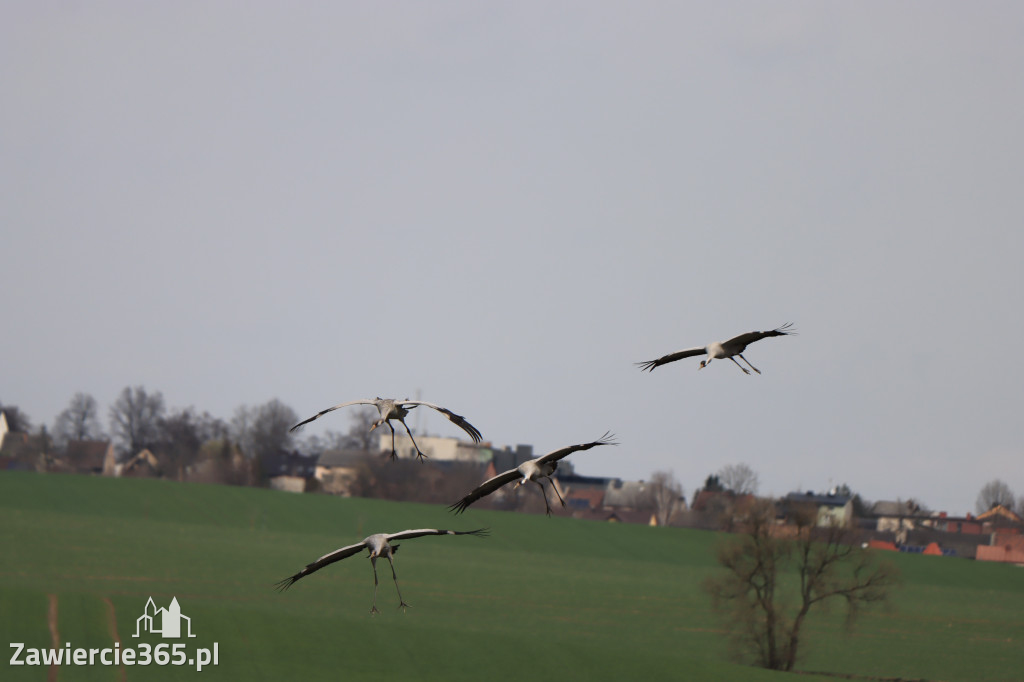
[0,1,1024,514]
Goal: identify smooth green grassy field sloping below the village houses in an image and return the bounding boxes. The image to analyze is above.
[0,473,1024,681]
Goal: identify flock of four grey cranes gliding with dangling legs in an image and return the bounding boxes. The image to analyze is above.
[276,323,796,613]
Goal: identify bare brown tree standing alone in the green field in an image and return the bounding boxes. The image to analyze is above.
[705,501,898,671]
